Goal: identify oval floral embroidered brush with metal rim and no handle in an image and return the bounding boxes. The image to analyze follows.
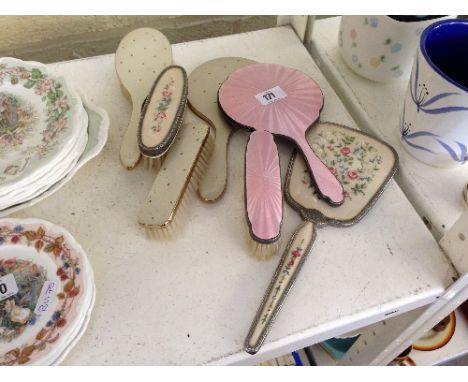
[138,65,187,169]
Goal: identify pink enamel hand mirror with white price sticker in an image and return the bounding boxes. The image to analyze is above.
[218,64,344,206]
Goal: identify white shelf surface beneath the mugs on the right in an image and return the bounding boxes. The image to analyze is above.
[312,17,468,239]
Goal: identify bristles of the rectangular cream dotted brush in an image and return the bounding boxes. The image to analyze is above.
[145,130,214,241]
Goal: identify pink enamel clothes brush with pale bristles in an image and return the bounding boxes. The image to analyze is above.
[245,131,283,260]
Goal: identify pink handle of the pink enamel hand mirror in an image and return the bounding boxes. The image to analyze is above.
[296,138,344,206]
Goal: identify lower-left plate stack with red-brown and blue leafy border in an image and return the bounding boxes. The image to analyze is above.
[0,219,94,365]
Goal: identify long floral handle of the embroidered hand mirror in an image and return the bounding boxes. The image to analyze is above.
[244,222,316,354]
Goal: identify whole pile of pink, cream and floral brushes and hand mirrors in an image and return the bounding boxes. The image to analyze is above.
[115,28,398,354]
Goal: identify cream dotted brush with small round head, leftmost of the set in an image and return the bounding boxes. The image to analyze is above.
[115,28,172,169]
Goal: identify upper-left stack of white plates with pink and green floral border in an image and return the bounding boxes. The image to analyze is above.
[0,58,108,215]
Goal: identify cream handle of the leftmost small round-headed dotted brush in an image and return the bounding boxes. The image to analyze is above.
[120,104,143,170]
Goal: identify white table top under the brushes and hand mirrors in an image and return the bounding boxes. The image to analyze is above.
[9,27,454,365]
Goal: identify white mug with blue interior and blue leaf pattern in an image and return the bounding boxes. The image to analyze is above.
[400,19,468,167]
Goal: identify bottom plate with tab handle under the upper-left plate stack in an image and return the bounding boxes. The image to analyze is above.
[0,98,109,217]
